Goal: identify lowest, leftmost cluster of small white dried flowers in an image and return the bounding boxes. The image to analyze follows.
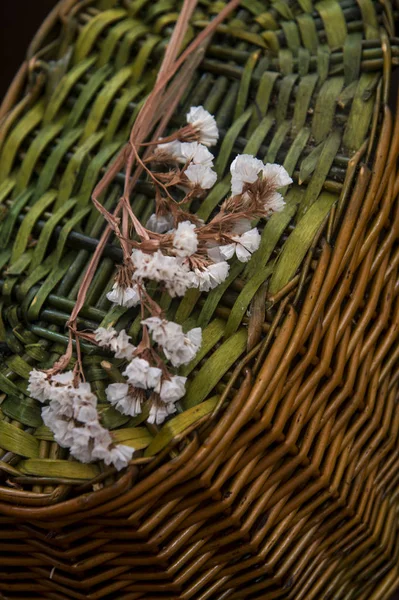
[28,369,134,470]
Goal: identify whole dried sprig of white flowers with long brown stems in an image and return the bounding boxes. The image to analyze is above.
[28,0,291,470]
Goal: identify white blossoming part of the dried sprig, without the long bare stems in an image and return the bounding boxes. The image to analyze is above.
[29,106,292,469]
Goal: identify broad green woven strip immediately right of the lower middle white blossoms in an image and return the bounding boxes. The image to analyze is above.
[183,329,247,409]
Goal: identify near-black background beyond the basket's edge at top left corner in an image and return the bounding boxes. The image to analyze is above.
[0,0,399,600]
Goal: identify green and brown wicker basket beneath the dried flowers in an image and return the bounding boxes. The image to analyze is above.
[0,0,399,600]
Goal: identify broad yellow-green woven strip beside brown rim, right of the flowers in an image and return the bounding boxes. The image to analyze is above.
[269,192,338,295]
